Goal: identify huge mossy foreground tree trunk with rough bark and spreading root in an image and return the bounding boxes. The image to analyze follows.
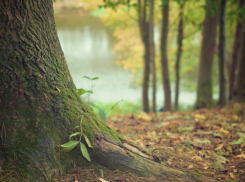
[0,0,183,182]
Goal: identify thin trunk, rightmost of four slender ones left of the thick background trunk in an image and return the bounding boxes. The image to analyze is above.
[174,4,184,111]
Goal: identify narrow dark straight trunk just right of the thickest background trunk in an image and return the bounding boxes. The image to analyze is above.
[217,0,226,105]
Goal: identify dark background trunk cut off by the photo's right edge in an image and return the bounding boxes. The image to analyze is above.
[234,21,245,102]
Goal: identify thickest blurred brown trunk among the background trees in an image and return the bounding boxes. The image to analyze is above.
[196,0,218,109]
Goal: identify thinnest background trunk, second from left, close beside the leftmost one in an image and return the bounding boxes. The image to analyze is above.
[149,0,156,112]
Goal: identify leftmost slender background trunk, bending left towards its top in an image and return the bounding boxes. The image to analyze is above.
[138,0,150,112]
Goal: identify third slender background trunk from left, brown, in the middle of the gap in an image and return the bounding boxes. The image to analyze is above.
[161,2,172,111]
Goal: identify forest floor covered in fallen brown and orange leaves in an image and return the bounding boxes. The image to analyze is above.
[55,104,245,182]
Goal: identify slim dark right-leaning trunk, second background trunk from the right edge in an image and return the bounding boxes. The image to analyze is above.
[229,0,245,102]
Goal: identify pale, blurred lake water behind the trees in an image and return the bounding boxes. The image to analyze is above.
[55,10,199,108]
